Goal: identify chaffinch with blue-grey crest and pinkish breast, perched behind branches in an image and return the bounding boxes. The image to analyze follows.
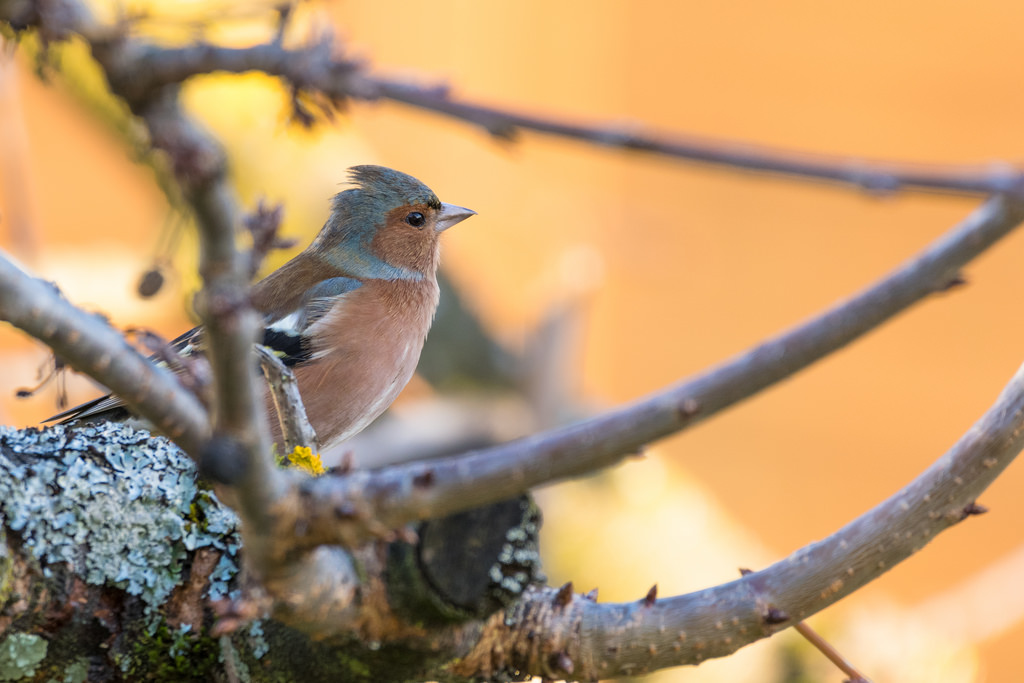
[47,165,476,447]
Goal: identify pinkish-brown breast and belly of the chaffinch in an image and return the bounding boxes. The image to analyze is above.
[271,278,438,445]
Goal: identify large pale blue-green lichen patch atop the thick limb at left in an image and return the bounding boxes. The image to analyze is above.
[0,423,239,610]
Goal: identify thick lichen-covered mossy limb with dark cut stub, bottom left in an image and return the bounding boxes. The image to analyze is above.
[0,423,552,681]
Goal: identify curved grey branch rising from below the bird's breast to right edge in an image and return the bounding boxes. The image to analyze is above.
[293,196,1024,545]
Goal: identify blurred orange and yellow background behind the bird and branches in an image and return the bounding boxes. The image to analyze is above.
[0,0,1024,683]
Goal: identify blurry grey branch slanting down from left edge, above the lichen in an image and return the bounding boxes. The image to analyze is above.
[0,254,210,459]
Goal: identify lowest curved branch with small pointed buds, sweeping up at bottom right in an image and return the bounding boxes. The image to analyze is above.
[459,360,1024,680]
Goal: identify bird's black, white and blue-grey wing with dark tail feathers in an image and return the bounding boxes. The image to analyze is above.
[43,278,362,423]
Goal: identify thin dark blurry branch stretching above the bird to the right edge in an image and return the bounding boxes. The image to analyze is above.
[66,32,1024,195]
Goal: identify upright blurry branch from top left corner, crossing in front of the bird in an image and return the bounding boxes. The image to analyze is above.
[51,0,287,567]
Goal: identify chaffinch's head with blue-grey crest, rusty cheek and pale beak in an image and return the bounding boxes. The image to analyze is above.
[310,166,476,280]
